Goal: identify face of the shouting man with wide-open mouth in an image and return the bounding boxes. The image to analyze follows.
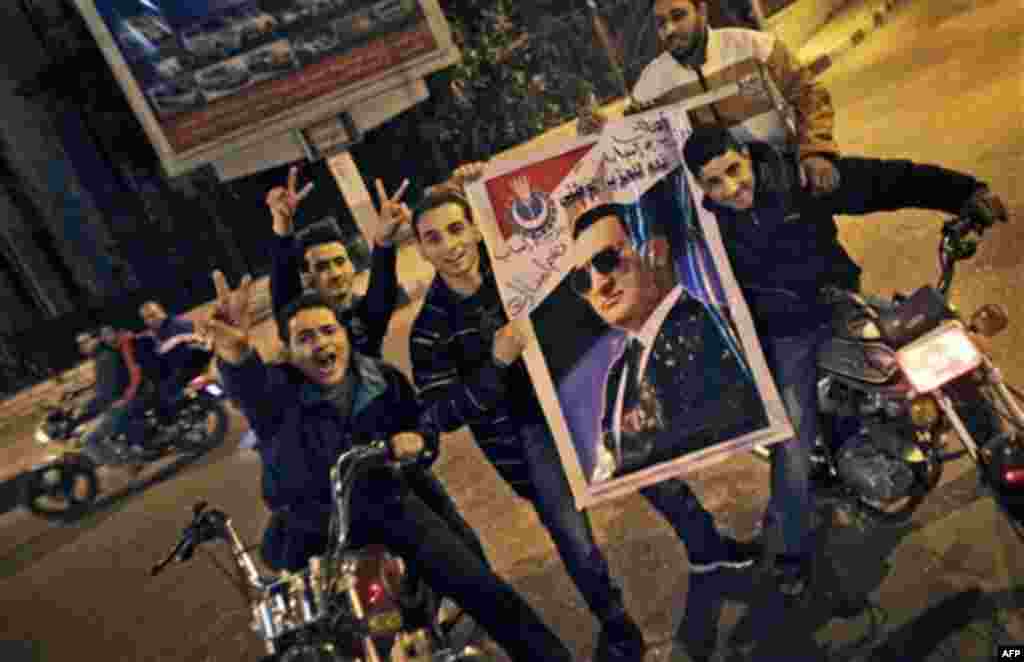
[288,307,351,385]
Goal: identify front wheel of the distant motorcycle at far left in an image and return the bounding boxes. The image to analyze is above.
[22,462,99,520]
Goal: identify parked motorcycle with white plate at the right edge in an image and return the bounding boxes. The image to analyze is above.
[755,213,1024,540]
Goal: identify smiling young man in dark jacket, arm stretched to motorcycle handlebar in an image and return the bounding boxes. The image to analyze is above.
[683,127,1007,597]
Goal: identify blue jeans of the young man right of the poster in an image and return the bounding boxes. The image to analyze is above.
[762,325,831,556]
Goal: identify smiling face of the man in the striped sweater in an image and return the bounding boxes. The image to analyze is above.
[418,202,480,278]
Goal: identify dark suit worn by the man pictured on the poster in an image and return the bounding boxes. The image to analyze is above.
[595,286,768,480]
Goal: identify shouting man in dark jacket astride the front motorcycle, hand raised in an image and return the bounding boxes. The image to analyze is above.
[207,272,571,662]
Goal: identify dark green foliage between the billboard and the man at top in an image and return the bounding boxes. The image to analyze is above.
[421,0,624,166]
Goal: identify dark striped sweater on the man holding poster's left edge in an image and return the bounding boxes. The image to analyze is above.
[410,246,545,496]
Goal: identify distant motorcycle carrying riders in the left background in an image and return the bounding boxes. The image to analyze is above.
[22,374,227,520]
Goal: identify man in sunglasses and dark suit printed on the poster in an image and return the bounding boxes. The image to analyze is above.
[569,204,767,480]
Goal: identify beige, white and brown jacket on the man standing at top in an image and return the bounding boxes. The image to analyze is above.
[628,28,839,157]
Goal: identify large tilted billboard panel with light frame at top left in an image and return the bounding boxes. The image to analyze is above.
[75,0,458,176]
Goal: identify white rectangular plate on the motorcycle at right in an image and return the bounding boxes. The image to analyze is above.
[896,321,982,394]
